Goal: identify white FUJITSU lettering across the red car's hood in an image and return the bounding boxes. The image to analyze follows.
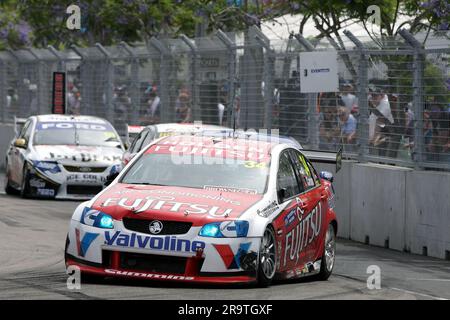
[101,196,233,217]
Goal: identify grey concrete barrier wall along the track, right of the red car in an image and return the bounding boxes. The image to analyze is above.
[315,161,450,260]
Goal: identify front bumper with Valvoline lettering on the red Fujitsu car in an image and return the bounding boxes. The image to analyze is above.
[66,220,261,283]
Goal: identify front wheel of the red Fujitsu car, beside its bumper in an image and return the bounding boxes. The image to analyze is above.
[257,227,277,287]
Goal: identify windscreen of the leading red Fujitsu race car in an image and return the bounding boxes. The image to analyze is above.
[121,153,269,194]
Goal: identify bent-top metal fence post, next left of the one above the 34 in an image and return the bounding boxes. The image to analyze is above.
[216,30,236,127]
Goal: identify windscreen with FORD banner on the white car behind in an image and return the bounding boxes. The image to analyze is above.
[33,122,121,147]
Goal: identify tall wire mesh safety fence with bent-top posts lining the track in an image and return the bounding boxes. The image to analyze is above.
[0,28,450,170]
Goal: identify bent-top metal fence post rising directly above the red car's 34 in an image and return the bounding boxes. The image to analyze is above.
[255,35,275,134]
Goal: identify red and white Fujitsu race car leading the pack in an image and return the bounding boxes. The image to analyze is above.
[65,135,337,286]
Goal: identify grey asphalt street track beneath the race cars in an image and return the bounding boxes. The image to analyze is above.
[0,186,450,300]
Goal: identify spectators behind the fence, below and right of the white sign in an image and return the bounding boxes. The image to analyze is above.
[318,83,450,162]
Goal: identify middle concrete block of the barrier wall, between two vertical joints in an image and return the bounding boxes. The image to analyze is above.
[350,164,411,250]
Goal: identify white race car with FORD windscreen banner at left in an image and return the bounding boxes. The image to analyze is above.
[5,115,124,199]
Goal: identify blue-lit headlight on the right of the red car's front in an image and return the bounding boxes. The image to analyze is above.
[198,220,249,238]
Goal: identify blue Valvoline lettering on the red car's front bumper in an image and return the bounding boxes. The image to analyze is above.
[105,231,206,253]
